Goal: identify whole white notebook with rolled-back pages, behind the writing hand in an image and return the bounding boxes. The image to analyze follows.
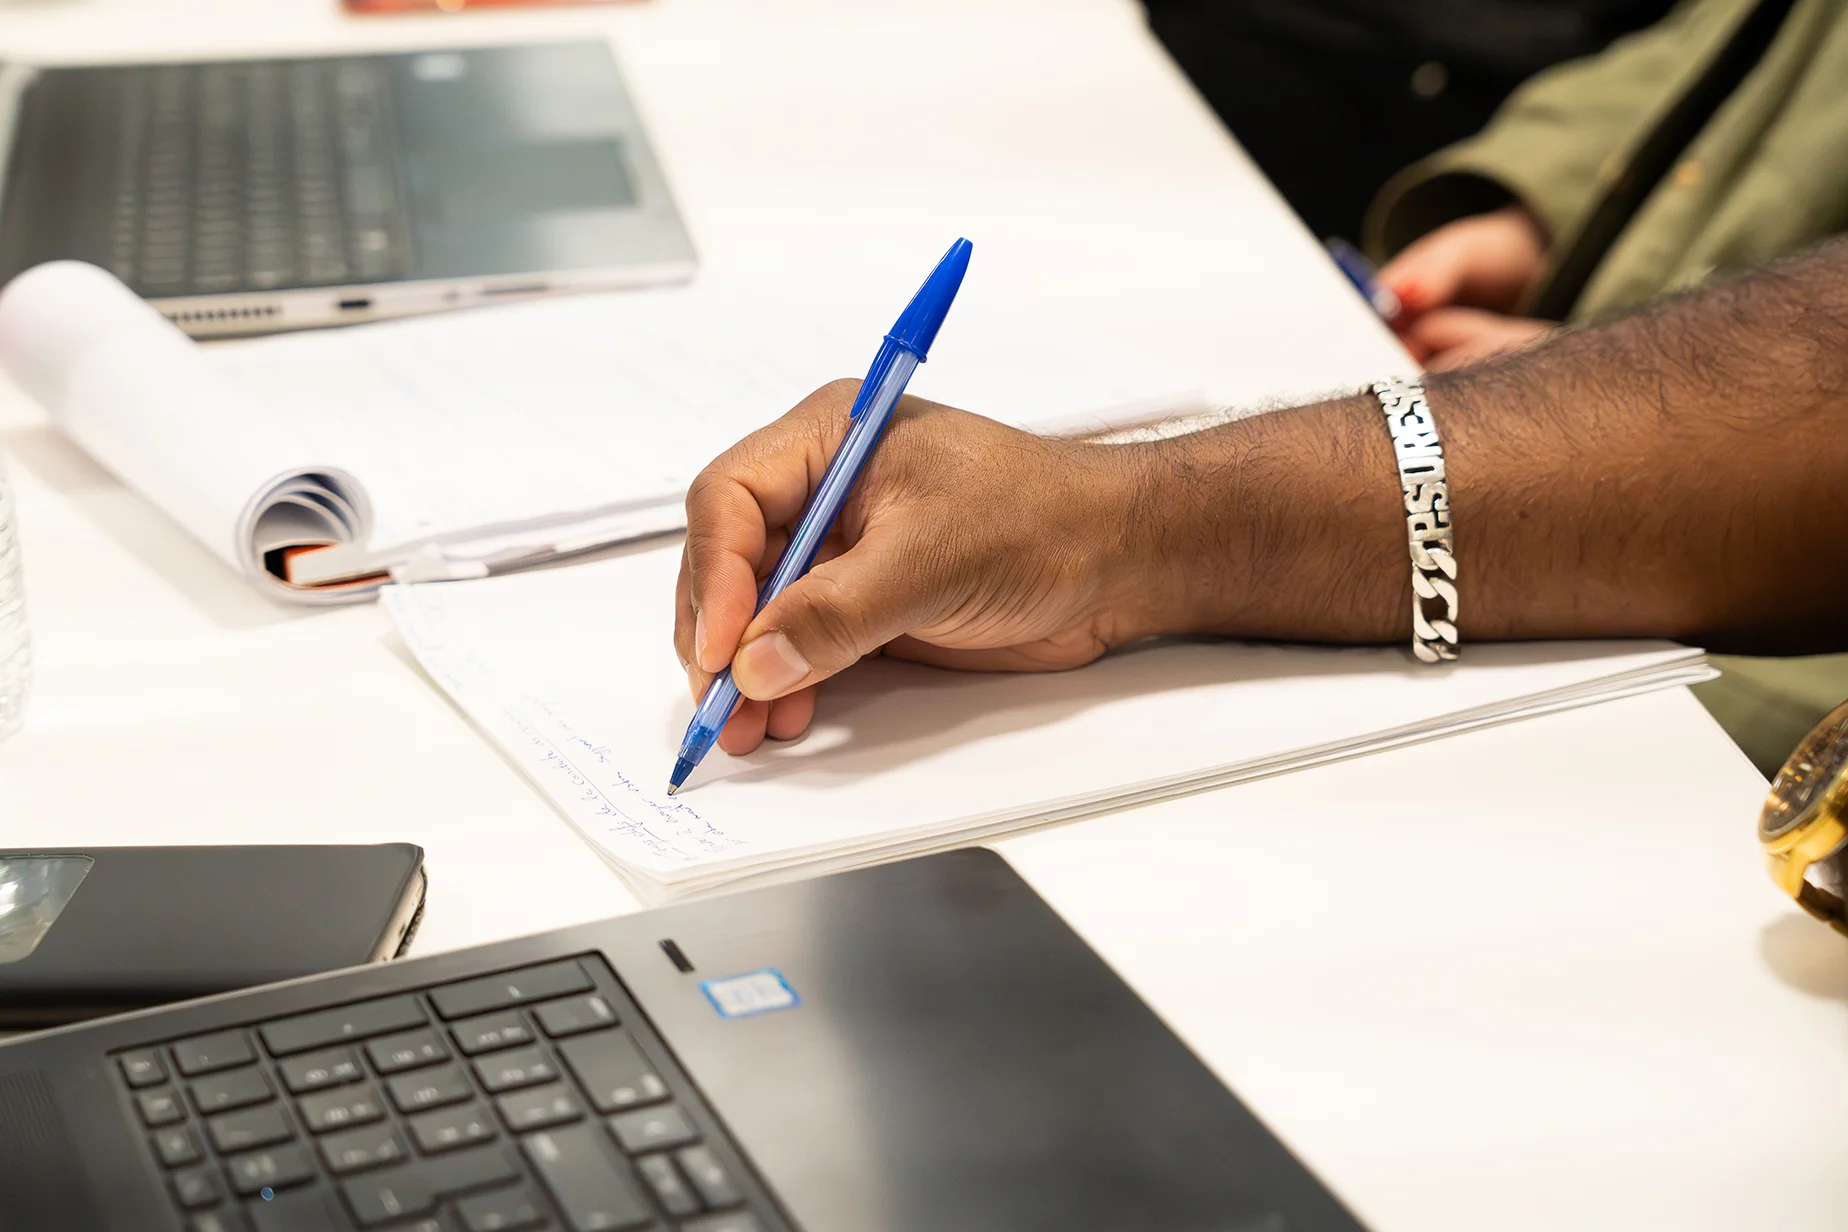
[0,262,1203,604]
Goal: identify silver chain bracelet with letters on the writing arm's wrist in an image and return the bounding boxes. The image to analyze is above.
[1373,377,1456,663]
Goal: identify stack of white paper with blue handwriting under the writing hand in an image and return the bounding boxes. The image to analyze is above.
[384,545,1711,901]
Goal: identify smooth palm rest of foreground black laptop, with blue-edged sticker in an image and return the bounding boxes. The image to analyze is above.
[612,852,1358,1232]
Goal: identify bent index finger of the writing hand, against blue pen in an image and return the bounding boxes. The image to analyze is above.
[678,380,859,672]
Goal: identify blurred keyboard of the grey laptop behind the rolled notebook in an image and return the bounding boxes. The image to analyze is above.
[107,59,410,297]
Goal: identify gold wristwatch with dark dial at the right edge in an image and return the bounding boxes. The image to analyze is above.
[1757,702,1848,935]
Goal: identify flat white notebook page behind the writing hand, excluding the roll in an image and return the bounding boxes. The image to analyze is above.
[207,286,1198,547]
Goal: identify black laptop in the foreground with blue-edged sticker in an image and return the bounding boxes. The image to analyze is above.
[0,852,1360,1232]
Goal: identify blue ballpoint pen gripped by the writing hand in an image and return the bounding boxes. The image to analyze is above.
[667,240,970,796]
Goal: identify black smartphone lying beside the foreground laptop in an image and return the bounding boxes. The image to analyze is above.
[0,842,425,1029]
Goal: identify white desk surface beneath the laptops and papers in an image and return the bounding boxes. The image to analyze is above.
[0,0,1848,1232]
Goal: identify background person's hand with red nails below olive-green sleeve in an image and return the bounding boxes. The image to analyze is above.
[1379,205,1552,371]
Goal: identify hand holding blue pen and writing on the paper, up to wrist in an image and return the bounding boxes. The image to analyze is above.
[675,380,1155,754]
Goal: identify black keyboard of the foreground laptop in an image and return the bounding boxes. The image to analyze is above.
[115,955,782,1232]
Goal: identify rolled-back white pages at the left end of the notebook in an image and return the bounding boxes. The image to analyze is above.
[0,260,377,604]
